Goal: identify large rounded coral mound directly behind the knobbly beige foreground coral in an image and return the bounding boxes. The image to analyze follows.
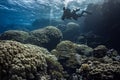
[26,26,63,50]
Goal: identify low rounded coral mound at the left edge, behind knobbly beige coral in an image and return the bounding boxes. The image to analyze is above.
[0,30,30,43]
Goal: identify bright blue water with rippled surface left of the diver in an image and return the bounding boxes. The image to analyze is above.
[0,0,104,32]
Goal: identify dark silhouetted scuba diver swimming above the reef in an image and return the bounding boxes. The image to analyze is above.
[62,7,92,20]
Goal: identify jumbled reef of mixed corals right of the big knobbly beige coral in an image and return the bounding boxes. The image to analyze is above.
[51,41,120,80]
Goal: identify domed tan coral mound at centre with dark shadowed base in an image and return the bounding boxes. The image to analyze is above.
[51,41,79,74]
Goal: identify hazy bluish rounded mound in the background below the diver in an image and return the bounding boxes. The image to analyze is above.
[63,22,80,41]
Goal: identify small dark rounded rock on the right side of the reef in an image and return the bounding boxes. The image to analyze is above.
[93,45,108,58]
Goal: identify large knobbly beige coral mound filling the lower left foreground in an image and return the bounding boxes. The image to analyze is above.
[0,41,49,80]
